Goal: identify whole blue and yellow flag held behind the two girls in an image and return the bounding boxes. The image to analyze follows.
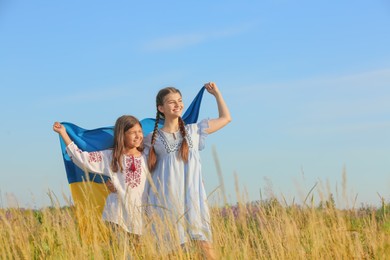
[60,87,205,234]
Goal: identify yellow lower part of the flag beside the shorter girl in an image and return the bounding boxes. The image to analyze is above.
[69,182,110,243]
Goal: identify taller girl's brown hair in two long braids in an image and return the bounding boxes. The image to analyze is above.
[148,87,189,172]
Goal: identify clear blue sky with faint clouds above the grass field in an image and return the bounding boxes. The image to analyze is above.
[0,0,390,207]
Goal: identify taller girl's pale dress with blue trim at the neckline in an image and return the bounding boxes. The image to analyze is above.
[144,120,212,249]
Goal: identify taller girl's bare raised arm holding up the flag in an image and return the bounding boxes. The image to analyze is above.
[204,82,232,134]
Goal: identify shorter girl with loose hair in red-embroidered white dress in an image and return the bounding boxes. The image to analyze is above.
[53,115,149,244]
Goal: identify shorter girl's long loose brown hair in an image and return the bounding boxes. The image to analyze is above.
[111,115,143,172]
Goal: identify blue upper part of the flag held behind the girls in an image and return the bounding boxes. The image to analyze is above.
[60,87,205,184]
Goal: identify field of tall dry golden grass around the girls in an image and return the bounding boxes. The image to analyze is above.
[0,188,390,259]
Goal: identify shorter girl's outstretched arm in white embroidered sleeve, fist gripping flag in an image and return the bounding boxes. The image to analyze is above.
[53,122,110,176]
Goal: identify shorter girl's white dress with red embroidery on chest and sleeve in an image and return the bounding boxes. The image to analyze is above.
[66,142,149,235]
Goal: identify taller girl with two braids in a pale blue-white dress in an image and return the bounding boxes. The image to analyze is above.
[144,82,231,259]
